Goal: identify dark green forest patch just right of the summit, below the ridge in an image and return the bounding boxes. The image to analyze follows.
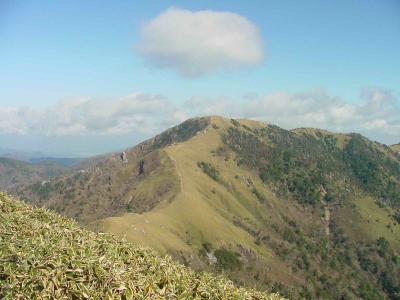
[223,126,342,204]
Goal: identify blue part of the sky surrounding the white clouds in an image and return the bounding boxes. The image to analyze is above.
[0,0,400,154]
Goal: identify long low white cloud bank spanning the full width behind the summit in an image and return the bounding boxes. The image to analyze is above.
[0,88,400,144]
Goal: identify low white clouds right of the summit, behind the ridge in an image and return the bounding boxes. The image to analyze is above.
[185,88,400,144]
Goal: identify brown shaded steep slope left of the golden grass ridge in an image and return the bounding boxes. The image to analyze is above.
[16,119,208,224]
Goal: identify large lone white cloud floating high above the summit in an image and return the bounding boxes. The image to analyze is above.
[138,8,263,77]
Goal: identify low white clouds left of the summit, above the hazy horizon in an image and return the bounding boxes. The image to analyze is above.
[0,93,186,136]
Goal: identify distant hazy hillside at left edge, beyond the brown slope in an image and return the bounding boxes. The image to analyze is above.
[0,157,67,189]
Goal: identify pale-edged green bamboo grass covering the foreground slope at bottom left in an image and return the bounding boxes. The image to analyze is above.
[0,193,281,300]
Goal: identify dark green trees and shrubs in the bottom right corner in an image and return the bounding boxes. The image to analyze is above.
[259,212,400,299]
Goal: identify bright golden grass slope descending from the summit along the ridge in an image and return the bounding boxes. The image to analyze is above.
[93,117,268,256]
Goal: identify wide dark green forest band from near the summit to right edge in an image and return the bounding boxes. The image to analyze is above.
[223,125,400,207]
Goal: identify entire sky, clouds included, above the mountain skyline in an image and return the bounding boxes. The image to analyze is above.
[0,0,400,156]
